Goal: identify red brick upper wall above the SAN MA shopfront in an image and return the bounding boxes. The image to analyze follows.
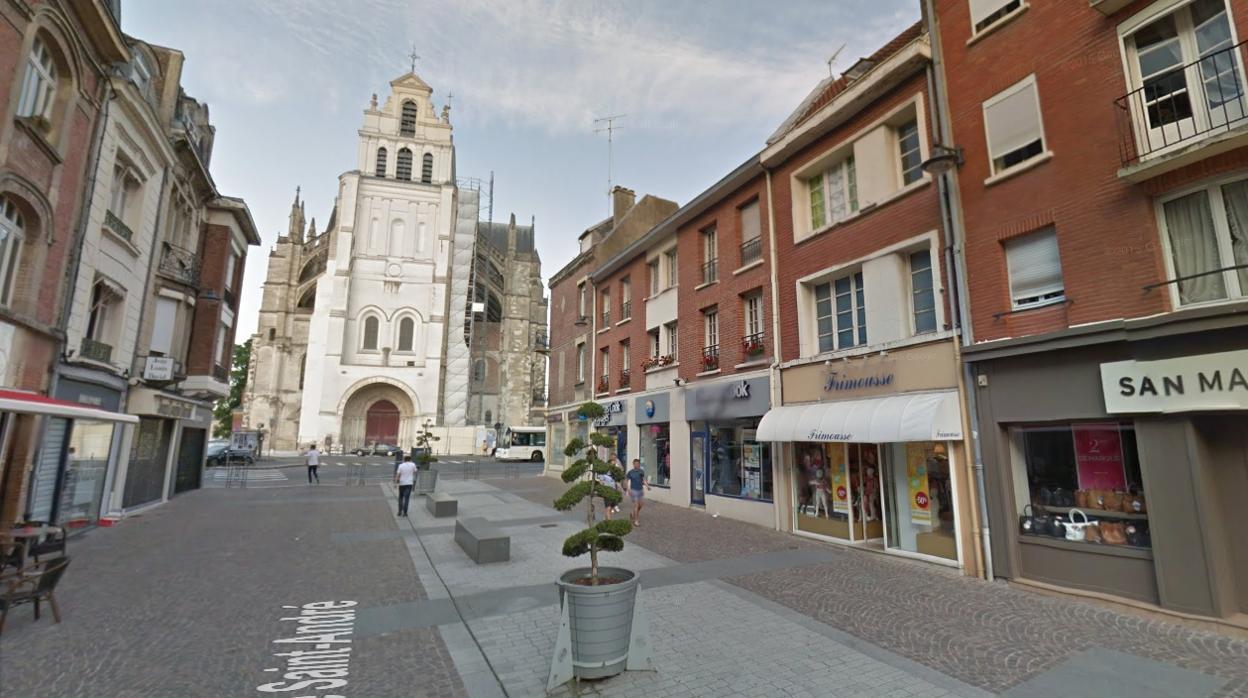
[936,0,1248,341]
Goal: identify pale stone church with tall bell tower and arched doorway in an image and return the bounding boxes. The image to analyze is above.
[243,72,545,451]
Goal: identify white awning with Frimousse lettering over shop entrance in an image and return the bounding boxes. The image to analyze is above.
[758,391,962,443]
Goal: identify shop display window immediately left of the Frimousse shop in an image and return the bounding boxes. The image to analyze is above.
[695,420,774,502]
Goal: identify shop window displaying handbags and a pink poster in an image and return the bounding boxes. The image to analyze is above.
[1010,422,1152,548]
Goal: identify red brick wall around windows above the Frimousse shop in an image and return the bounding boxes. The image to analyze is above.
[769,74,950,361]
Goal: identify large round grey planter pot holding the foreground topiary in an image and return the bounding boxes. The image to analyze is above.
[555,567,640,678]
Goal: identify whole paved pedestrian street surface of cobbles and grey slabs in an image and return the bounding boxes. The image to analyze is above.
[0,471,1248,698]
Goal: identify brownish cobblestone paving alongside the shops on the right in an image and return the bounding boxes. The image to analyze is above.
[490,477,1248,697]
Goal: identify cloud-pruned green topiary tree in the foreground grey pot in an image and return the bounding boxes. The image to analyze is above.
[554,402,633,587]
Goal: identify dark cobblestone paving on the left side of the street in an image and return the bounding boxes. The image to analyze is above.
[0,486,467,698]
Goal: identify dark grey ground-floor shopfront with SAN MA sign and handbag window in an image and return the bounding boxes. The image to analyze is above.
[965,320,1248,618]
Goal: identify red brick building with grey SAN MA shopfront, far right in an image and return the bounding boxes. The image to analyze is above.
[926,0,1248,617]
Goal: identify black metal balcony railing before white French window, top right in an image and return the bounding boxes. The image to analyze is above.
[1113,41,1248,166]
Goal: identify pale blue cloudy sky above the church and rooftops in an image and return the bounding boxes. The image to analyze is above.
[121,0,919,341]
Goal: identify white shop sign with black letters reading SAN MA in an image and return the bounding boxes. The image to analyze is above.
[1101,350,1248,415]
